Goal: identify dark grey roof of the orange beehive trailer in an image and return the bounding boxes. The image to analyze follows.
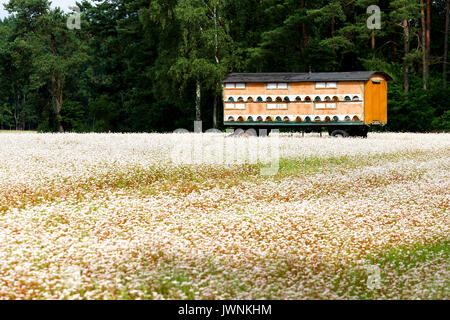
[222,71,392,83]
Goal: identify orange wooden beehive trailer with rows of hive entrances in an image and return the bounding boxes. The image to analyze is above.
[223,71,392,137]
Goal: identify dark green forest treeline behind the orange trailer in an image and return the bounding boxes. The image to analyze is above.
[0,0,450,132]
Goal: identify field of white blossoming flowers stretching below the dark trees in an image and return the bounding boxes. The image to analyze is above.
[0,133,450,299]
